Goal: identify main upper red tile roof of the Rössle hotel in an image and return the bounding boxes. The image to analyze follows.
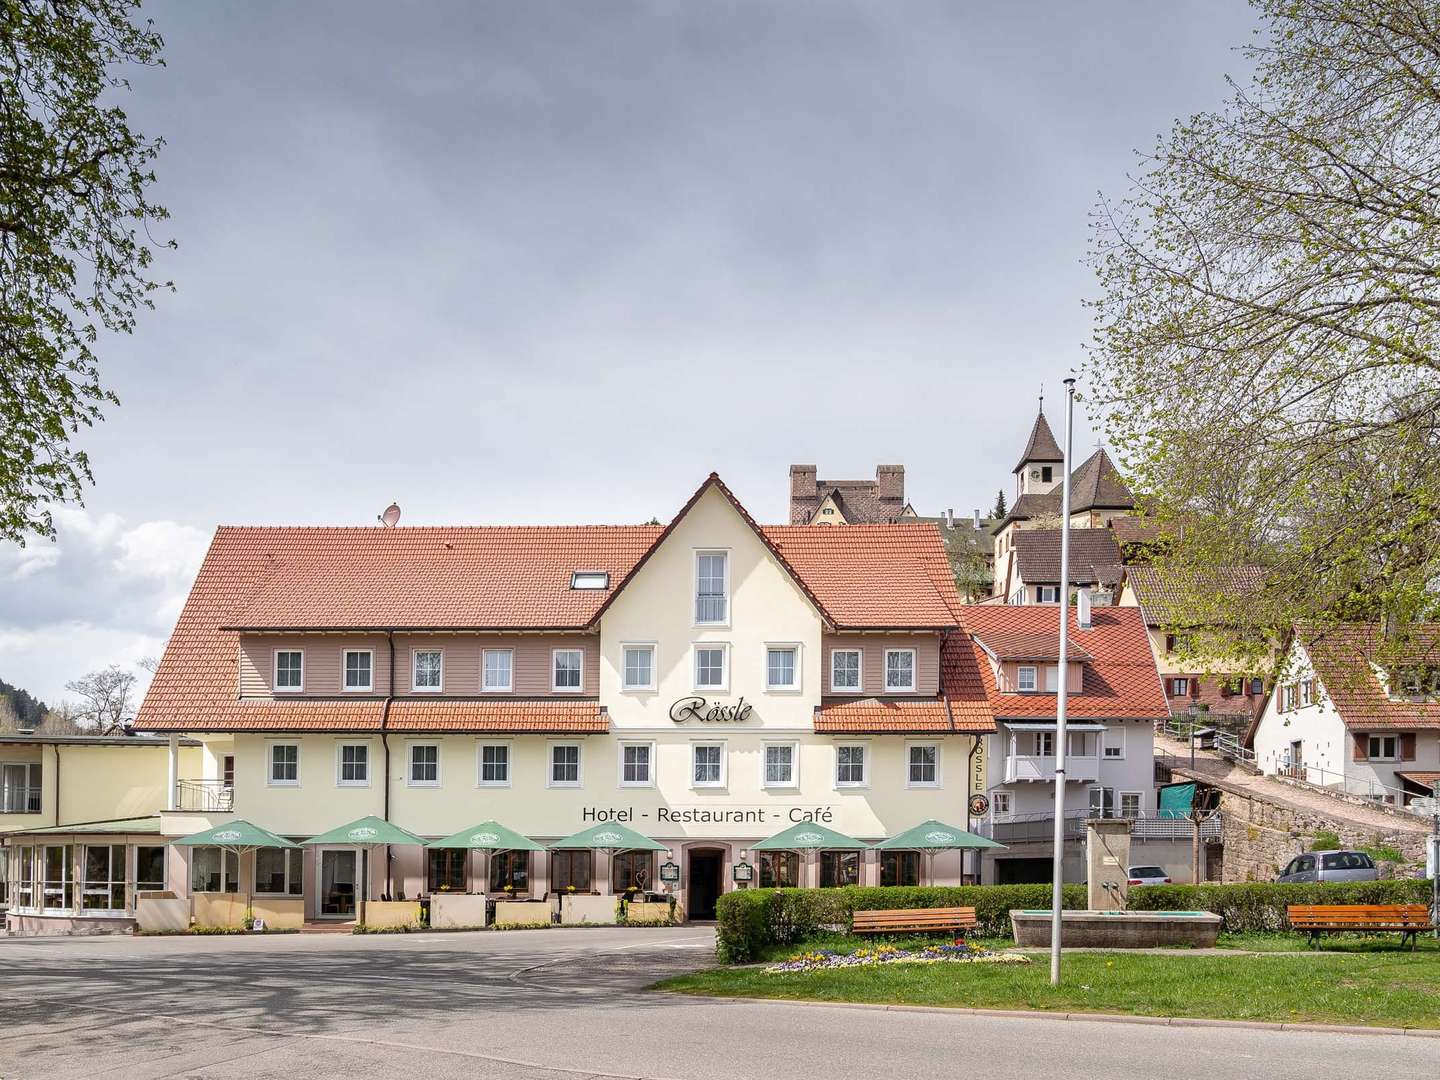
[135,474,960,732]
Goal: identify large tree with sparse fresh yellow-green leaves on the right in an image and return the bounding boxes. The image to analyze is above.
[1087,0,1440,665]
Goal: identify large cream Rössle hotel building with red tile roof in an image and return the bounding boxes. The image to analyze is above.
[70,474,994,920]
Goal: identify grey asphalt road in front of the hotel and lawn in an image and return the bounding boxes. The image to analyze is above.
[0,929,1437,1080]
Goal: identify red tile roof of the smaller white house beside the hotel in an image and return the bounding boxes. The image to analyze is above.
[960,603,1169,720]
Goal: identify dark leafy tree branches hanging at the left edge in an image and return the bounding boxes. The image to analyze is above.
[0,0,168,541]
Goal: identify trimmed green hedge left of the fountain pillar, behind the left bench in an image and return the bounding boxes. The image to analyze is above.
[716,886,1086,963]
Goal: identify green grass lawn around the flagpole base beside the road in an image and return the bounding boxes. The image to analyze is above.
[657,936,1440,1028]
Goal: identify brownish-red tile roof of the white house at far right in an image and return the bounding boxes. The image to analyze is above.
[1299,622,1440,732]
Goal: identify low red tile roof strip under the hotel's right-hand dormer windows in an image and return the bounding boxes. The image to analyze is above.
[815,632,995,734]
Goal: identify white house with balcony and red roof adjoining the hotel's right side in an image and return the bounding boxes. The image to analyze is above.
[960,605,1169,883]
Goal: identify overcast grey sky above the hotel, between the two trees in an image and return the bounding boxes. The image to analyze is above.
[0,0,1254,701]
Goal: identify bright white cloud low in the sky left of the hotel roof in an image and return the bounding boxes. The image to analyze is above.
[0,507,209,704]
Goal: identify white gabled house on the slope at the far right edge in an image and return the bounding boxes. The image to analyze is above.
[1246,624,1440,805]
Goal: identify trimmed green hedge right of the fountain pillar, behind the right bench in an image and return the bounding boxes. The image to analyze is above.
[1129,878,1430,933]
